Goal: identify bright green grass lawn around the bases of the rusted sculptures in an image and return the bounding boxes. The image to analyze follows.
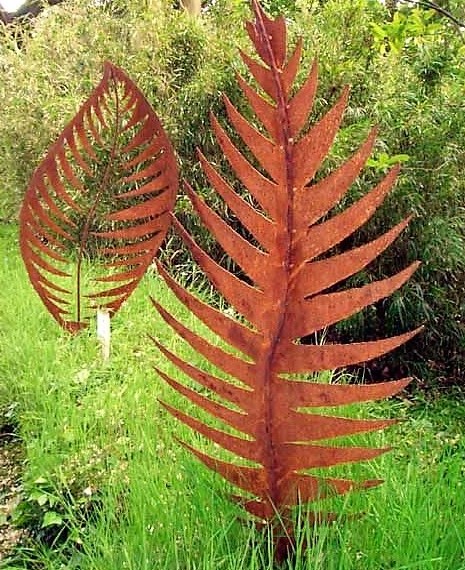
[0,226,465,570]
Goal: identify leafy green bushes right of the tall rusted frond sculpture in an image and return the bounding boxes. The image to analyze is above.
[300,2,465,381]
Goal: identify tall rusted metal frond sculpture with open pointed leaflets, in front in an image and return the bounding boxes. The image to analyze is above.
[153,1,417,557]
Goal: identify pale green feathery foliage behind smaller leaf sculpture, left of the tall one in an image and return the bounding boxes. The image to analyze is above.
[0,0,242,219]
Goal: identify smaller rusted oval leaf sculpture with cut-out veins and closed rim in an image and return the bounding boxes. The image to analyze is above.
[20,62,178,332]
